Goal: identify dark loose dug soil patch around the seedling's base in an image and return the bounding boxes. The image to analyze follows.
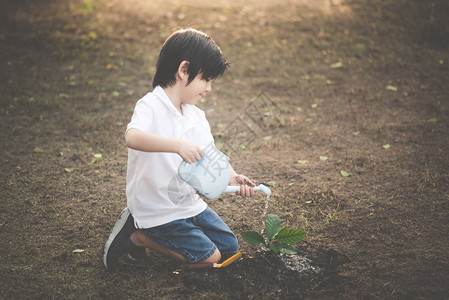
[176,250,349,298]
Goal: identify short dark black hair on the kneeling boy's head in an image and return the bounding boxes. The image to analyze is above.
[153,28,229,88]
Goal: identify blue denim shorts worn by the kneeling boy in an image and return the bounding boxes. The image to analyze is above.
[143,207,238,263]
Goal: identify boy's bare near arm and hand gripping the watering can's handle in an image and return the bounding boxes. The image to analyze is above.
[126,128,203,164]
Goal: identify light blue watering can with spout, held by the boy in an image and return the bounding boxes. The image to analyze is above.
[178,144,271,199]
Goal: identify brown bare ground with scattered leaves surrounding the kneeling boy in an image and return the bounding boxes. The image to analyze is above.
[0,0,449,299]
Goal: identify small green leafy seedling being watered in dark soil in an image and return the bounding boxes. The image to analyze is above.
[241,214,307,254]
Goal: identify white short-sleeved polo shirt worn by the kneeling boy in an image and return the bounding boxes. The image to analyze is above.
[126,86,214,228]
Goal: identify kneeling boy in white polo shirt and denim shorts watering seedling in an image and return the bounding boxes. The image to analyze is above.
[103,29,254,271]
